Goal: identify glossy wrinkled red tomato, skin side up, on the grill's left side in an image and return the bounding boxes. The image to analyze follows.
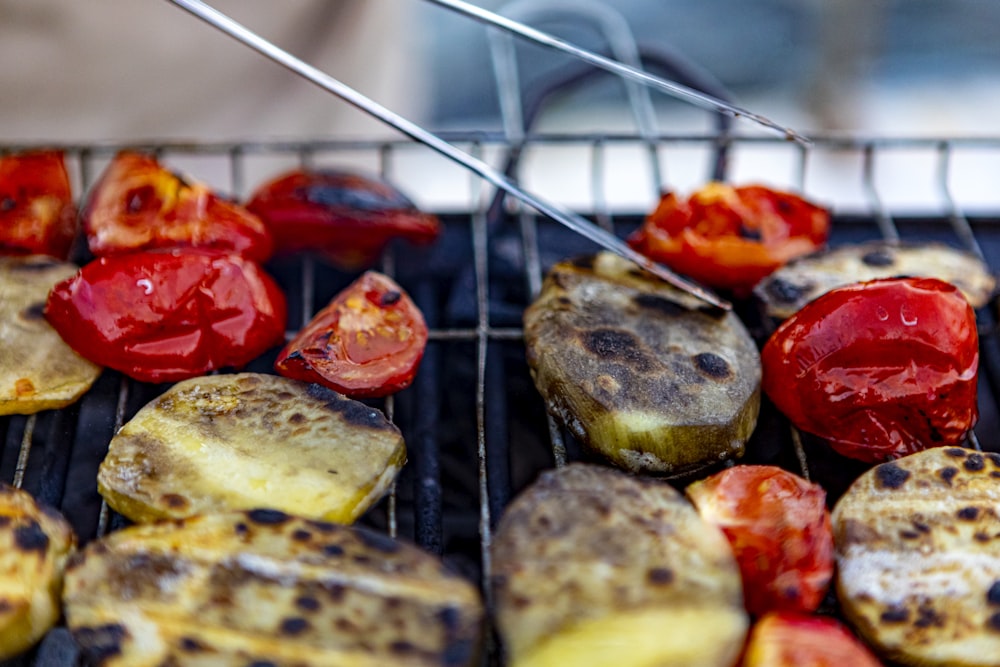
[45,248,286,382]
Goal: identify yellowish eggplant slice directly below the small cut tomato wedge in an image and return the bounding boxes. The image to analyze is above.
[97,373,406,523]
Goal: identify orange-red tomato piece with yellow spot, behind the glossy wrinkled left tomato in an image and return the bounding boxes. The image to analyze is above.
[83,151,273,262]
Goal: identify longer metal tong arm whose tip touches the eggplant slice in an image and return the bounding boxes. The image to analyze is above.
[167,0,732,310]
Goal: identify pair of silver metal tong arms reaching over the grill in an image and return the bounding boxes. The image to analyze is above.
[162,0,804,310]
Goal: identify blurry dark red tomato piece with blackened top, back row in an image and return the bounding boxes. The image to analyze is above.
[247,170,441,271]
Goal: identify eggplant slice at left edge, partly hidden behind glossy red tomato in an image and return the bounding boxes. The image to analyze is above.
[0,255,101,415]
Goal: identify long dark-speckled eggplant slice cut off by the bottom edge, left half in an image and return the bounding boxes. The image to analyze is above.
[63,510,483,667]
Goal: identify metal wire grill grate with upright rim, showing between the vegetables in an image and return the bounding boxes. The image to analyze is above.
[0,133,1000,665]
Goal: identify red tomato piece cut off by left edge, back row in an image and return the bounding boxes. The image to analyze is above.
[0,151,77,259]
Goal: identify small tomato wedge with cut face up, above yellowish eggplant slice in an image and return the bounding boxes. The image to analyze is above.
[275,271,427,398]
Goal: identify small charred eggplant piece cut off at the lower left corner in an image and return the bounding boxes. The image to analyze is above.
[0,484,76,659]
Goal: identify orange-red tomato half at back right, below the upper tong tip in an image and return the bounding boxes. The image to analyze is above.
[628,183,830,295]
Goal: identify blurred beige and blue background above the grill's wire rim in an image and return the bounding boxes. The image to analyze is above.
[0,0,1000,141]
